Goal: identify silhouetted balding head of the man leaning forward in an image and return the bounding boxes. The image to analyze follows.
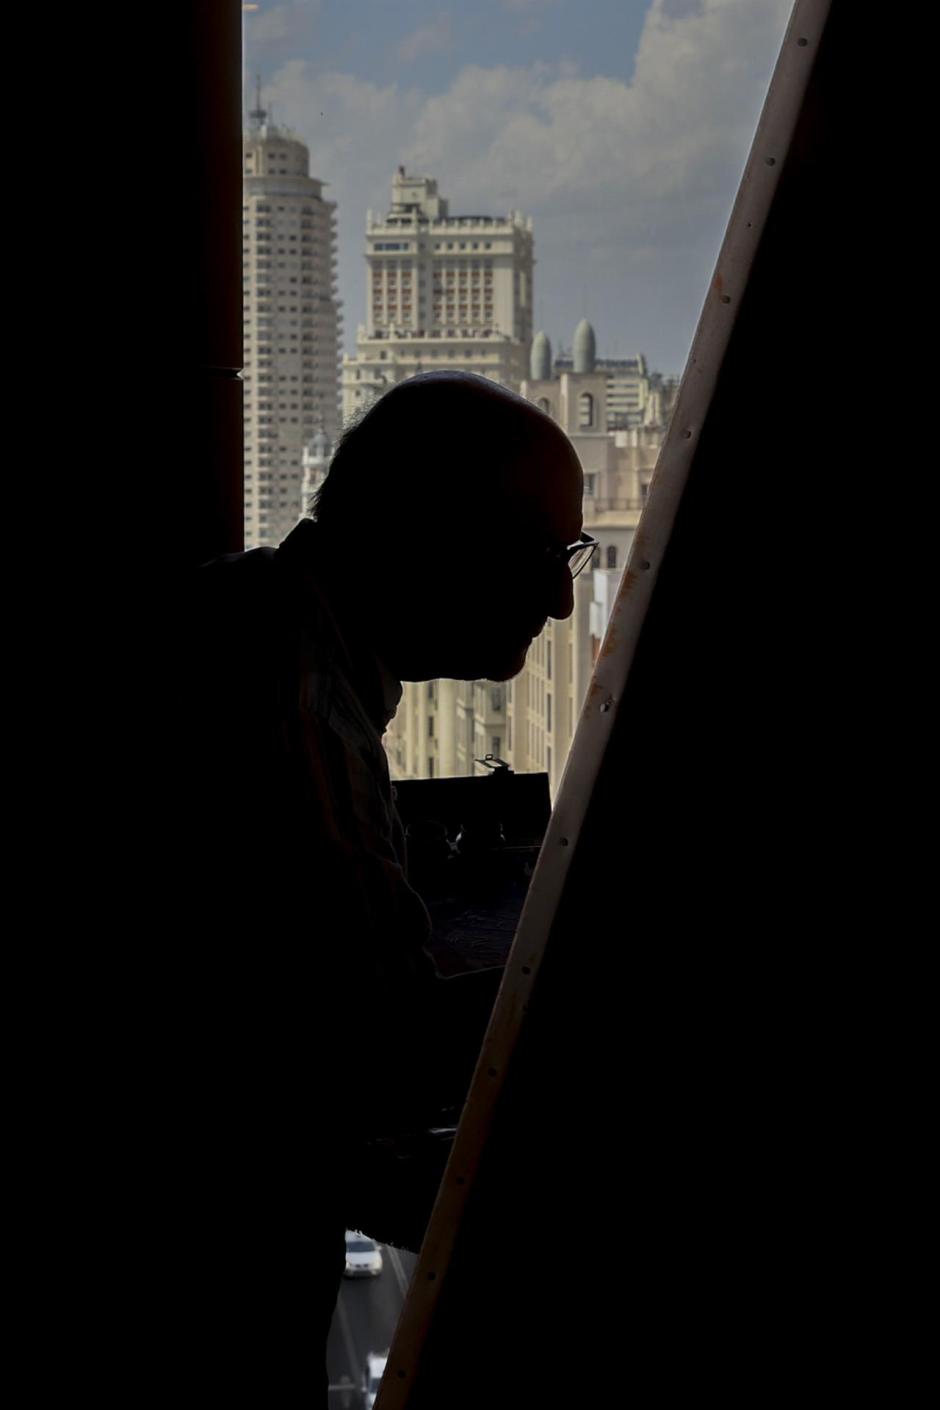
[314,372,582,680]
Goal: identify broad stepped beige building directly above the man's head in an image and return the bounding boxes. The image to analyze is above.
[342,166,534,422]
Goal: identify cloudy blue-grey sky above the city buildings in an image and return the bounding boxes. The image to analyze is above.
[244,0,791,374]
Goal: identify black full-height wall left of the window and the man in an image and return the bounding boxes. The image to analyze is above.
[16,0,241,1404]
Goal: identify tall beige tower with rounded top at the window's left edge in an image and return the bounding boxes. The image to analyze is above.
[242,100,341,548]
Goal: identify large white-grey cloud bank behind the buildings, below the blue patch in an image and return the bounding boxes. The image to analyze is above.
[268,0,789,369]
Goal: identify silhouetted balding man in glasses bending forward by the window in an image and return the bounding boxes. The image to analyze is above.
[176,374,589,1392]
